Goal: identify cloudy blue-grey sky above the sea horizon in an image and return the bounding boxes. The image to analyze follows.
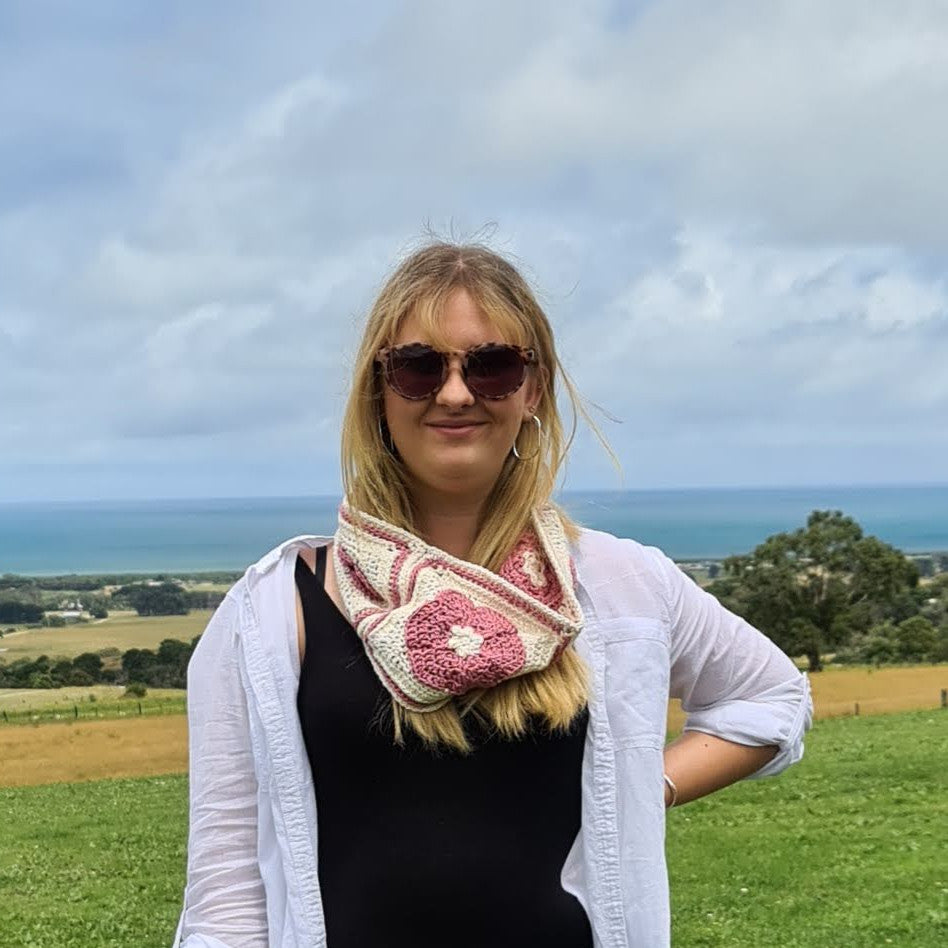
[0,0,948,501]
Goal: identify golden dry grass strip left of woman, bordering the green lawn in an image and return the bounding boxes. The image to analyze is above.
[0,714,188,787]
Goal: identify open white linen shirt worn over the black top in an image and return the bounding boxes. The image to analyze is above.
[174,530,812,948]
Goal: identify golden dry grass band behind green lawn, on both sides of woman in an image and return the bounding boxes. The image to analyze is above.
[0,665,948,786]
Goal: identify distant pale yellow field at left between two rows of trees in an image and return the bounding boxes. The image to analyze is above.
[0,609,212,664]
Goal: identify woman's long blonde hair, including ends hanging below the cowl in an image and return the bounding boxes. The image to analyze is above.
[342,241,598,752]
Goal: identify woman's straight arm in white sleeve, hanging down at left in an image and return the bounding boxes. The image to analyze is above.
[175,595,267,948]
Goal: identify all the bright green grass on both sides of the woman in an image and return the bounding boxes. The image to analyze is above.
[0,711,948,948]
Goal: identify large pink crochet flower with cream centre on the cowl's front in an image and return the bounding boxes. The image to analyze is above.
[405,589,526,695]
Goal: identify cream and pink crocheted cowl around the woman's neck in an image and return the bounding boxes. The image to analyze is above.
[333,502,583,711]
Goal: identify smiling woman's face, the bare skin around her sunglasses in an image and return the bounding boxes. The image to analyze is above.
[383,289,540,503]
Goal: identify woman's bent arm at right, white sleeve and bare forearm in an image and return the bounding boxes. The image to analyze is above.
[653,550,813,804]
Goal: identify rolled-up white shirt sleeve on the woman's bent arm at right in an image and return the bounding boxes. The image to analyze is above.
[651,548,813,778]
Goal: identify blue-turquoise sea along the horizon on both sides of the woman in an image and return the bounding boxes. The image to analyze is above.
[0,486,948,575]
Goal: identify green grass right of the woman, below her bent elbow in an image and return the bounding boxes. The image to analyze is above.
[668,710,948,948]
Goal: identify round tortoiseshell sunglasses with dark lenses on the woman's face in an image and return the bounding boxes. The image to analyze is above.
[376,342,537,401]
